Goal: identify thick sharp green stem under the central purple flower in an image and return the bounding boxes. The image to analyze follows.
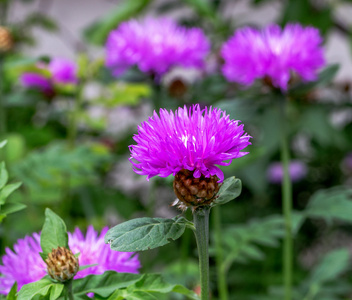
[193,206,210,300]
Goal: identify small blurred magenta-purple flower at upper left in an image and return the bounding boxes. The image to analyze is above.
[20,58,78,94]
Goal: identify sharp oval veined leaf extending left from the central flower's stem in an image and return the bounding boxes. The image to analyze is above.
[105,217,187,252]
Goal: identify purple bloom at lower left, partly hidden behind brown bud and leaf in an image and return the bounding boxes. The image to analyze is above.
[0,226,140,294]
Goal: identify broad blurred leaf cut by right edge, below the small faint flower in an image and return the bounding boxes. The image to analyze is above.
[304,187,352,222]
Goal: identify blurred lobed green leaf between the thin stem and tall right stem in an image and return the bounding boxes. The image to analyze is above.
[216,215,284,270]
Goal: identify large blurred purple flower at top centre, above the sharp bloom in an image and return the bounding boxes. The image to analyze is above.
[106,18,210,76]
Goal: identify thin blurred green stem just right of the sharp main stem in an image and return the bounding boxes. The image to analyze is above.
[212,206,229,300]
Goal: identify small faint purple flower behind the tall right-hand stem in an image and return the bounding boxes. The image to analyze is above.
[267,160,308,183]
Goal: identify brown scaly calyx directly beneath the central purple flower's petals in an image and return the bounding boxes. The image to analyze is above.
[173,169,220,209]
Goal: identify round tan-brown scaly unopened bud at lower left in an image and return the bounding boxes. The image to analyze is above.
[45,247,79,282]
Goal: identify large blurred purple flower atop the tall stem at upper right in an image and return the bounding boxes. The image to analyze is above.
[221,24,325,90]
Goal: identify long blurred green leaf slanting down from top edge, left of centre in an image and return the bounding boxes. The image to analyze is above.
[83,0,151,46]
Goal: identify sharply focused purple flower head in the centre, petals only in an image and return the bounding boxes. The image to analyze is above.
[130,105,251,181]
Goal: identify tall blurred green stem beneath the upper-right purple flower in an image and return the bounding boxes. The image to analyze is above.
[280,99,293,300]
